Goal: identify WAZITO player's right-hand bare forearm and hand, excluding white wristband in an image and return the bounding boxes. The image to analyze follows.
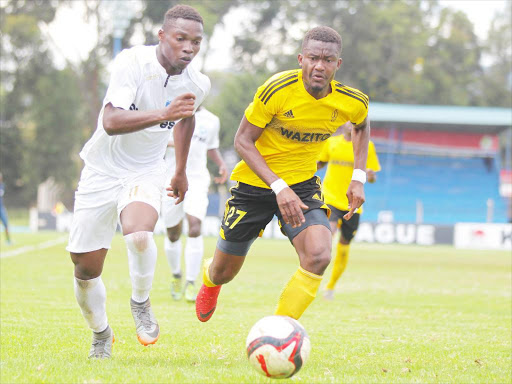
[343,118,370,220]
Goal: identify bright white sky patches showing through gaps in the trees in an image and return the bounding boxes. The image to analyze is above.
[45,0,512,71]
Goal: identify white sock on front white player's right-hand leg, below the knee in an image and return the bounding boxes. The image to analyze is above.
[124,231,157,303]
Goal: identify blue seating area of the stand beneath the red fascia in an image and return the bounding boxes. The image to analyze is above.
[364,152,507,224]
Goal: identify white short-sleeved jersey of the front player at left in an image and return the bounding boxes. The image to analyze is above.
[80,45,210,178]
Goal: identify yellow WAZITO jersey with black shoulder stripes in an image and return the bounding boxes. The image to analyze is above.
[231,70,369,188]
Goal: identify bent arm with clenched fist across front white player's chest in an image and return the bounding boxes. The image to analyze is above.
[103,93,196,136]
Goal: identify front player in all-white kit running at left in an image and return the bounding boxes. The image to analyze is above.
[67,5,210,359]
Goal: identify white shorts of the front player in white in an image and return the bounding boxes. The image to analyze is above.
[66,166,167,253]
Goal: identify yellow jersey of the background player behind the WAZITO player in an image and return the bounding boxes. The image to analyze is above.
[318,136,380,213]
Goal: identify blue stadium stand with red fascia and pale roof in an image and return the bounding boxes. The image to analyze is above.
[319,103,512,224]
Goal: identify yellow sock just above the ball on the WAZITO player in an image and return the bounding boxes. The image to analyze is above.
[275,267,322,319]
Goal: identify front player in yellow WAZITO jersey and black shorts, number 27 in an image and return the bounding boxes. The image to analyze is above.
[196,27,370,322]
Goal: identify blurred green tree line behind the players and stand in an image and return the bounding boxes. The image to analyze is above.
[0,0,512,207]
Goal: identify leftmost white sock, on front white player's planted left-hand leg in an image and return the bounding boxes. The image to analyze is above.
[75,276,108,333]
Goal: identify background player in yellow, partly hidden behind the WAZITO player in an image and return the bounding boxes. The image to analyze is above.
[318,123,380,300]
